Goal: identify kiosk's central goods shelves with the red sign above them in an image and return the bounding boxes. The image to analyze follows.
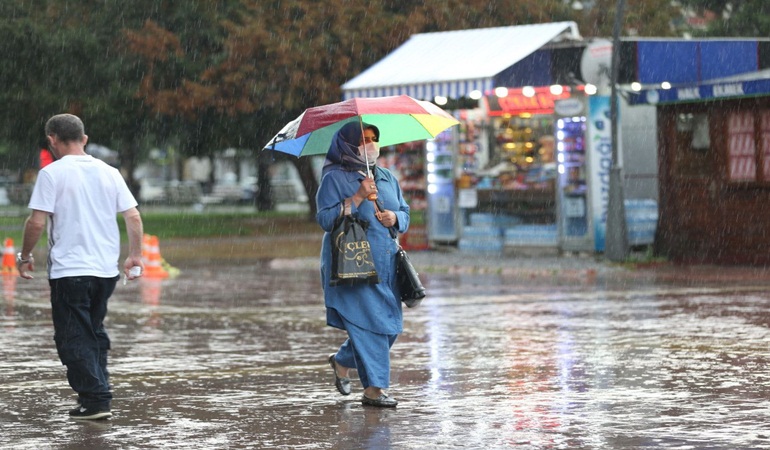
[459,86,570,229]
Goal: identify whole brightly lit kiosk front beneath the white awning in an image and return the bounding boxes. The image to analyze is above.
[389,88,611,252]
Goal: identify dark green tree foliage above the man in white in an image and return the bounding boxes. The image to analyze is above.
[0,0,240,192]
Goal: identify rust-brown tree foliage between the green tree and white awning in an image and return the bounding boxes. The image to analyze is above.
[128,0,580,216]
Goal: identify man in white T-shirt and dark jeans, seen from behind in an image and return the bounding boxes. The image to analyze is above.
[16,114,144,419]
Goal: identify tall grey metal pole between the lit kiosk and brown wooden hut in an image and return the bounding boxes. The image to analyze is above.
[605,0,628,262]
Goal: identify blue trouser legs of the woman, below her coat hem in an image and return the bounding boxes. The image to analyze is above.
[335,316,398,389]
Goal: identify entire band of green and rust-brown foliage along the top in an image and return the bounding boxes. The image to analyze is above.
[0,0,688,178]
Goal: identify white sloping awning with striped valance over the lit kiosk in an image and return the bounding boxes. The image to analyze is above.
[342,22,580,100]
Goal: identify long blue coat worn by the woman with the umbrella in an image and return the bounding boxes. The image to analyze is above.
[316,167,409,334]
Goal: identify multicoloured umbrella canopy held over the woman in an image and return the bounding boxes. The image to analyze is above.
[264,95,459,157]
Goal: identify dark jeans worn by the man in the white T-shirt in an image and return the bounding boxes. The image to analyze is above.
[48,277,119,409]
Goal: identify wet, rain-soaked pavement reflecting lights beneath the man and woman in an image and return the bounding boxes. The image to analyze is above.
[0,264,770,449]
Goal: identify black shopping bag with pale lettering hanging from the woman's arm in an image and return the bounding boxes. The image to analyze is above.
[329,214,380,286]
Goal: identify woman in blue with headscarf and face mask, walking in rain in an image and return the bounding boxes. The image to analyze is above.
[316,122,409,407]
